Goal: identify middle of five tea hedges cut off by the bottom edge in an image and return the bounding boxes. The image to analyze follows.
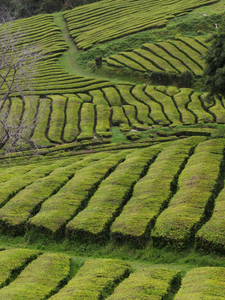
[50,258,130,300]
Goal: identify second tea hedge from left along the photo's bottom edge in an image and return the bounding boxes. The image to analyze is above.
[0,253,70,300]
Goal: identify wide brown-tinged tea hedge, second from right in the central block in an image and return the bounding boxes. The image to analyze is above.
[152,139,224,247]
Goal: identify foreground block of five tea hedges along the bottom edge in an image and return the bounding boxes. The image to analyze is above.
[0,248,225,300]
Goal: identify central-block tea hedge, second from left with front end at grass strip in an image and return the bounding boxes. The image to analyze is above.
[28,151,131,235]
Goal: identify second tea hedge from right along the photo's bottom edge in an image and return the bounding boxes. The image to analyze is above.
[107,266,181,300]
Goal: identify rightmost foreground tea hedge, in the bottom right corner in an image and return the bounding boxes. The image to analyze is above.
[174,267,225,300]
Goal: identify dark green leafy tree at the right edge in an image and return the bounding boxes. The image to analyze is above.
[204,27,225,97]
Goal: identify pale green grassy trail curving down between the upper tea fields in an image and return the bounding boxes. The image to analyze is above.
[53,12,127,83]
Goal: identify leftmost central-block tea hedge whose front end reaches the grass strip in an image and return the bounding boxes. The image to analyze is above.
[0,162,95,235]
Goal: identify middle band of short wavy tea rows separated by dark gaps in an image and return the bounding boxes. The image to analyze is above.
[0,85,225,147]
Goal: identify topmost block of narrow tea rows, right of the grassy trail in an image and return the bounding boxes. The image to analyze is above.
[64,0,214,49]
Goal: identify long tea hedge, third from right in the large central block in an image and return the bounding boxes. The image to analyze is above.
[111,137,205,243]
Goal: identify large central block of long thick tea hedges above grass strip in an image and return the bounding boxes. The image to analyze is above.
[0,137,225,251]
